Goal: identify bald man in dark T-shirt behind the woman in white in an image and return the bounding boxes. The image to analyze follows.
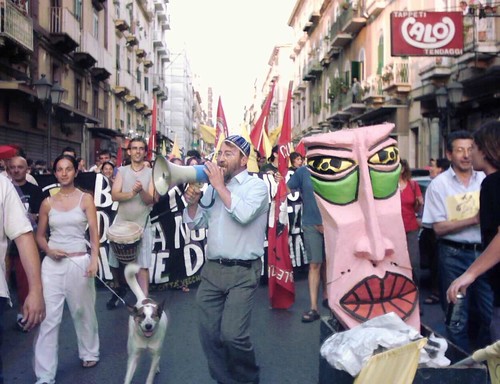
[7,156,43,330]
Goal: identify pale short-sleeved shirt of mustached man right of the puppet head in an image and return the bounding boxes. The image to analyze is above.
[422,167,485,243]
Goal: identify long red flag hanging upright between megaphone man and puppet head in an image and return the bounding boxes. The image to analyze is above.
[267,83,295,309]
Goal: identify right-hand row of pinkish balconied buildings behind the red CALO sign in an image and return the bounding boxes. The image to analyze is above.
[289,0,500,166]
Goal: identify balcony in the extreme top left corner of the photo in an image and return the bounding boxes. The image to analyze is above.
[0,1,33,52]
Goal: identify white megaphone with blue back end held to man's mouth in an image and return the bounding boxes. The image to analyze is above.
[153,156,208,196]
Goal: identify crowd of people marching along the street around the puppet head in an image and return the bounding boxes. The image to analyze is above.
[0,122,500,384]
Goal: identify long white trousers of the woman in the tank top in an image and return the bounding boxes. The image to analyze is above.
[34,255,99,384]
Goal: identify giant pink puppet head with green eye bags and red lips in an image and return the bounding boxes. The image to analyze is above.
[303,124,420,330]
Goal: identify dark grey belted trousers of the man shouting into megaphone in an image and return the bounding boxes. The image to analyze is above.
[196,259,262,384]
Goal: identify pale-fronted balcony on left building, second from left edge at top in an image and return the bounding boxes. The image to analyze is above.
[50,7,80,53]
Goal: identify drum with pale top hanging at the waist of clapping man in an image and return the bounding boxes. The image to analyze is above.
[106,221,143,264]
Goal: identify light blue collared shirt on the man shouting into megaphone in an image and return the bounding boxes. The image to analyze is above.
[183,170,269,260]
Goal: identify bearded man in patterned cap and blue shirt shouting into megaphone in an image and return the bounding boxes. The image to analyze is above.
[183,135,269,383]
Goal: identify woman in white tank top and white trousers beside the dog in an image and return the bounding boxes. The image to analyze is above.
[34,155,99,384]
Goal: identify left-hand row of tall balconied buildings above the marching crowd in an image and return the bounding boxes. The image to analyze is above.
[0,0,170,165]
